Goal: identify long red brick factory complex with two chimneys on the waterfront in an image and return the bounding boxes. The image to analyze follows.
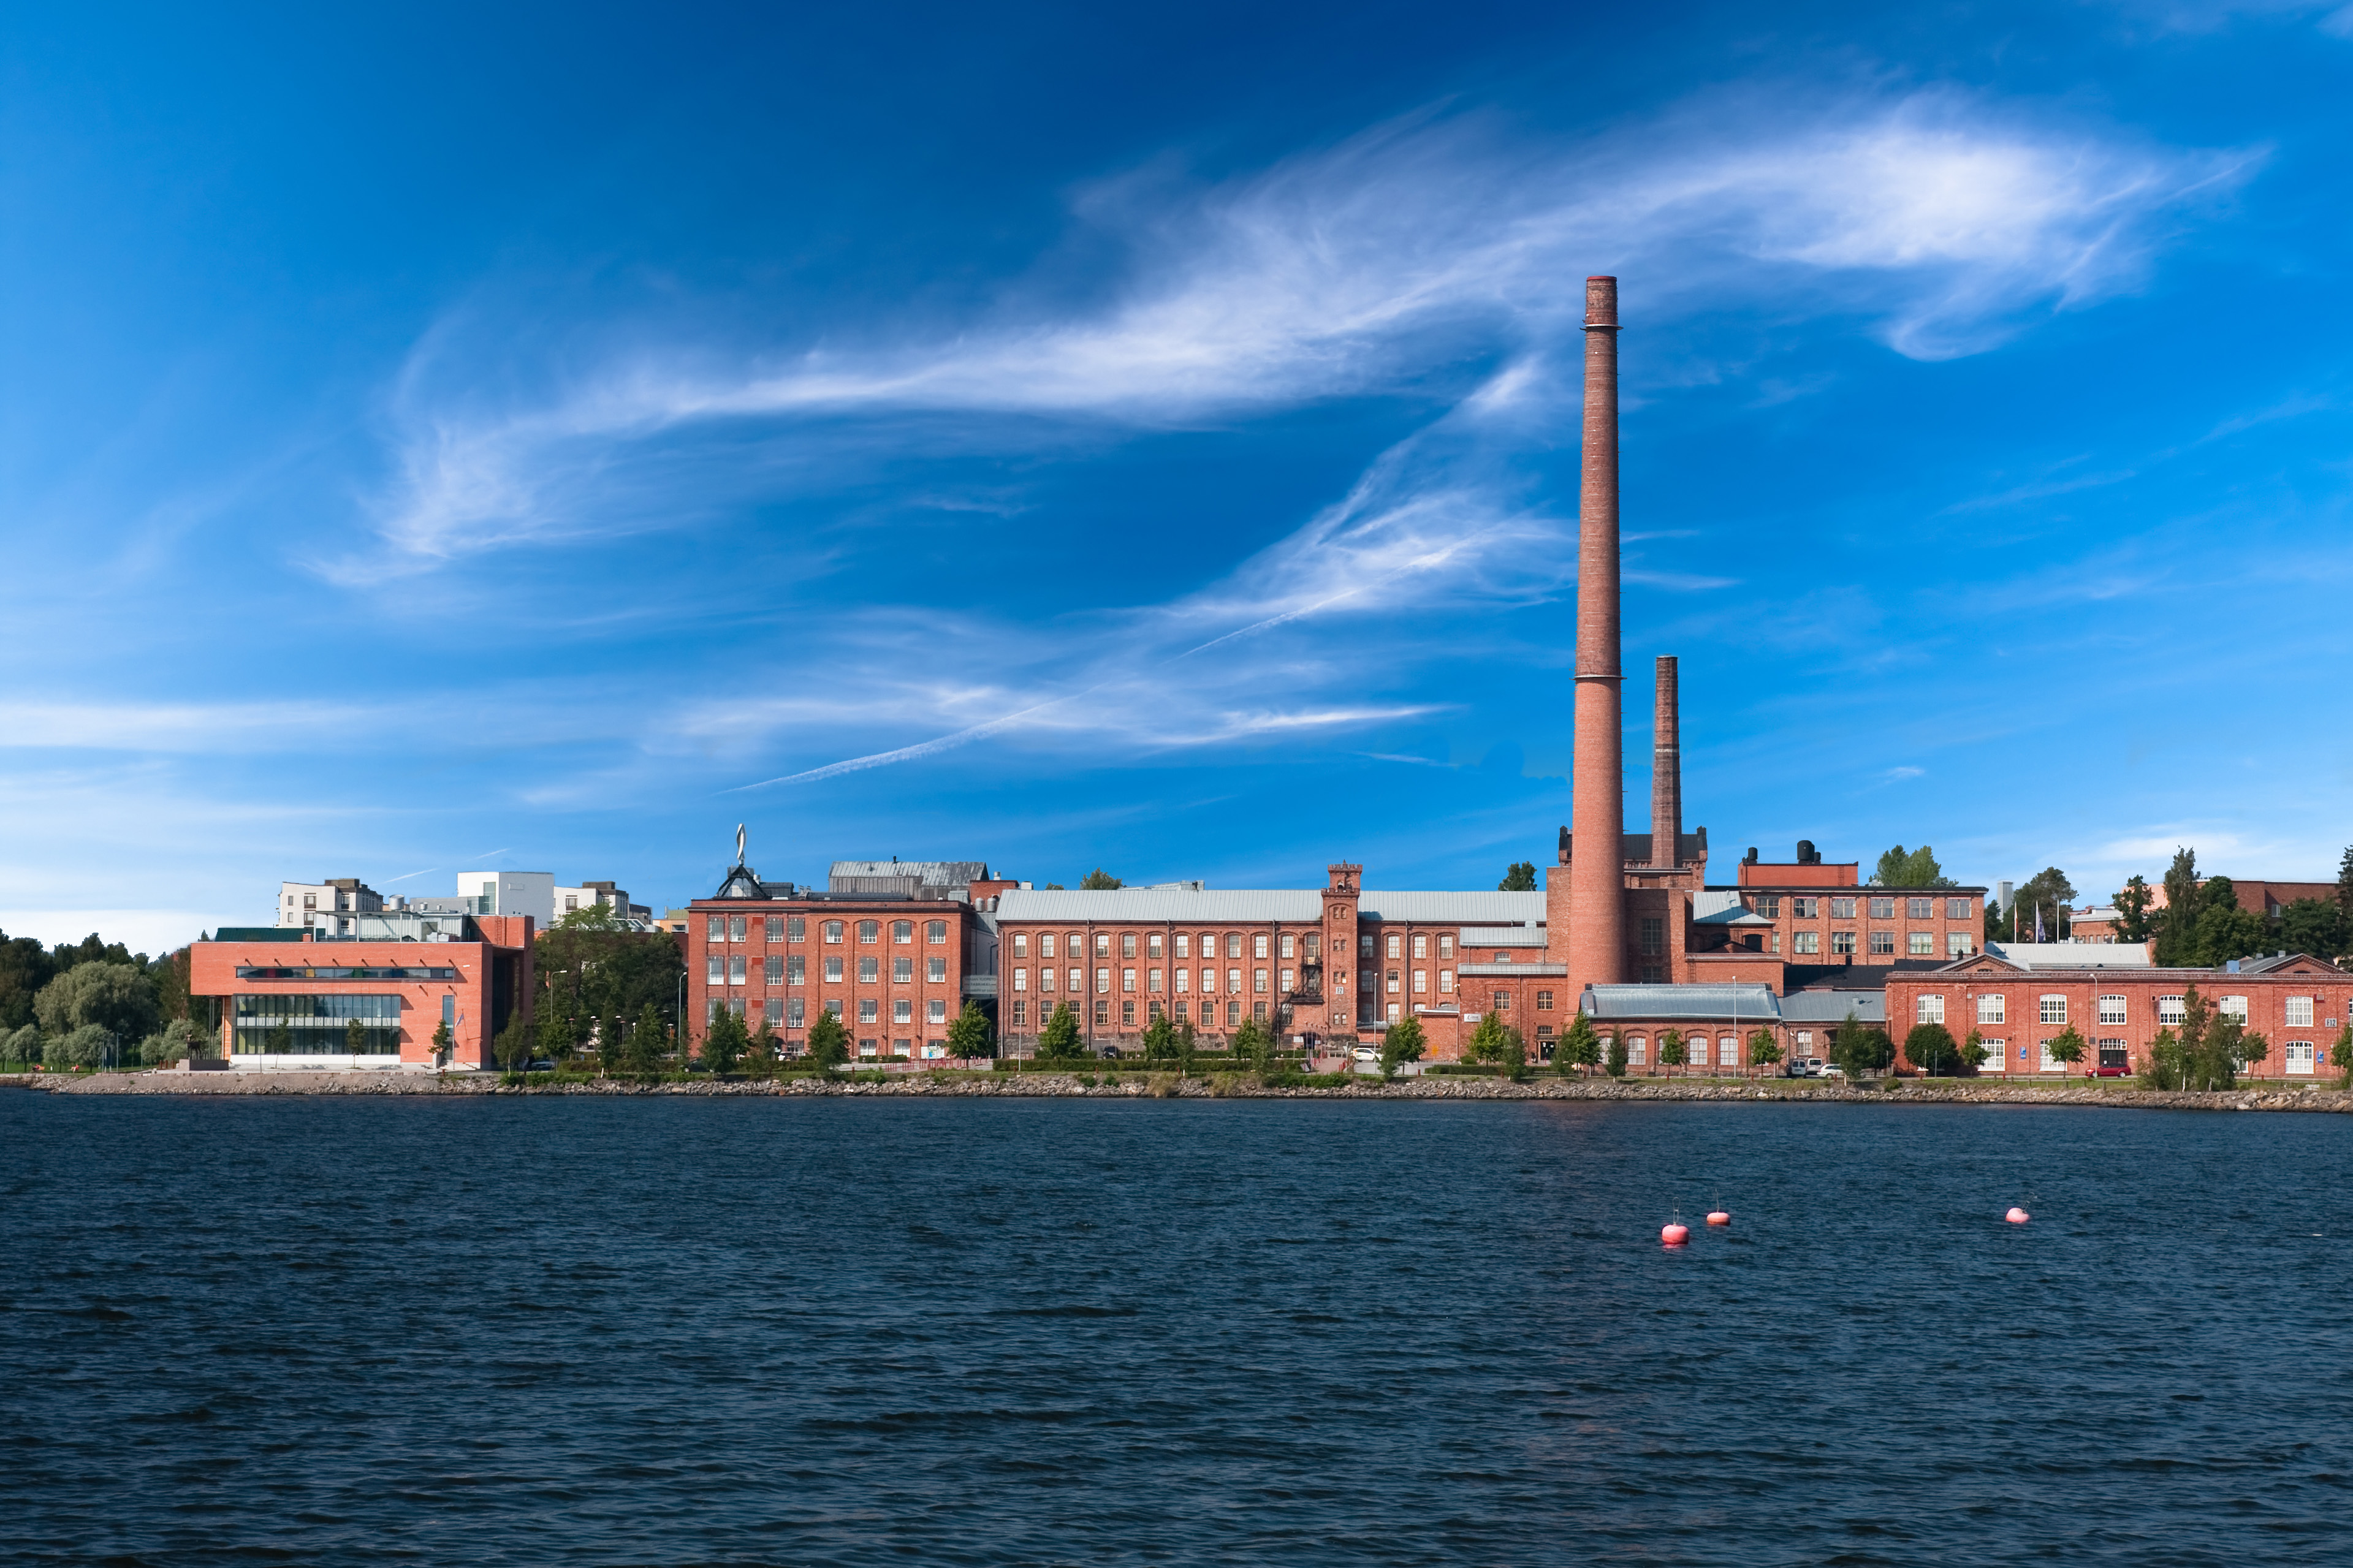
[687,278,2336,1070]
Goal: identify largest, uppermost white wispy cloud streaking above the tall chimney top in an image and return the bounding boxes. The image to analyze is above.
[357,85,2257,571]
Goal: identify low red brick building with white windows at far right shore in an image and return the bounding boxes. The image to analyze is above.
[1887,952,2353,1079]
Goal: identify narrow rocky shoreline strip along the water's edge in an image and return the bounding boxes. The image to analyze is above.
[13,1072,2353,1112]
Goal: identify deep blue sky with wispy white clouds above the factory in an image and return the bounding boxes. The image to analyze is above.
[0,5,2353,947]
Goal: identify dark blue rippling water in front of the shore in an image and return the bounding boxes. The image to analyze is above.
[0,1093,2353,1563]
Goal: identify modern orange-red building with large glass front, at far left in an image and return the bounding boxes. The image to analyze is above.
[188,914,536,1070]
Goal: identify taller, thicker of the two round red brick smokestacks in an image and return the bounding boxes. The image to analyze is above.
[1567,278,1626,994]
